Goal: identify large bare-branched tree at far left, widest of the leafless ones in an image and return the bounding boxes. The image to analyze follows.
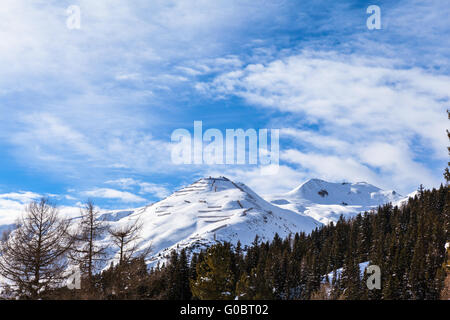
[0,198,72,299]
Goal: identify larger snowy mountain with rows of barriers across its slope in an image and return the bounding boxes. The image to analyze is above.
[105,177,321,263]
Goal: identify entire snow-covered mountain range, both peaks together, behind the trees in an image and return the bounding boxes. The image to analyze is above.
[0,177,412,265]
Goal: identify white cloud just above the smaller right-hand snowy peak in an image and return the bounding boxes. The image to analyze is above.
[280,129,440,193]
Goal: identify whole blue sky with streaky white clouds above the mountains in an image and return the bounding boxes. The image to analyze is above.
[0,0,450,212]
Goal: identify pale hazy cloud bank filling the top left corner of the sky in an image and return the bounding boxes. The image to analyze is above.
[0,0,282,92]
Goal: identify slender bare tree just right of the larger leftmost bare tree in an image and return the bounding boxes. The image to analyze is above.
[70,200,107,287]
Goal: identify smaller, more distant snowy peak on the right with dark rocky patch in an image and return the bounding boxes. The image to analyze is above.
[270,179,404,224]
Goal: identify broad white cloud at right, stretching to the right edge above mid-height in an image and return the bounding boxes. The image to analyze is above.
[205,53,450,157]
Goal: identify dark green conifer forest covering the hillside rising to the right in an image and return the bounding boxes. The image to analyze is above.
[34,186,450,299]
